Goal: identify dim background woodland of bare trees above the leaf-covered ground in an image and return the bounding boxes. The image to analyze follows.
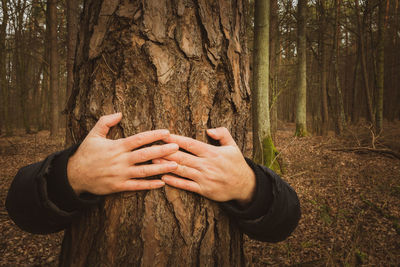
[0,0,400,136]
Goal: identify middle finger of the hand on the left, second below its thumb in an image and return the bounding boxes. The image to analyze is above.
[129,143,179,164]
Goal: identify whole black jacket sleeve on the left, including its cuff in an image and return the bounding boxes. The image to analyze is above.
[6,145,98,234]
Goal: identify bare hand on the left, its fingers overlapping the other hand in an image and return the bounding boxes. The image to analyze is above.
[67,113,179,196]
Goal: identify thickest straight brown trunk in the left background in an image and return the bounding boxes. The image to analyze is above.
[47,0,60,136]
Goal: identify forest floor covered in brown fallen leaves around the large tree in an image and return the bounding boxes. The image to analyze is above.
[0,122,400,266]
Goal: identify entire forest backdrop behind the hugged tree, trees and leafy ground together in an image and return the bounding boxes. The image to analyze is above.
[0,0,400,266]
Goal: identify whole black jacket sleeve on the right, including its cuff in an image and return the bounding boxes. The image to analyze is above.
[221,159,301,242]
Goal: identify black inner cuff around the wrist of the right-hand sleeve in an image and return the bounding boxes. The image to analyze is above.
[221,158,273,220]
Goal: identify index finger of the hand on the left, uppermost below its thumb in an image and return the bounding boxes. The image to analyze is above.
[122,129,169,151]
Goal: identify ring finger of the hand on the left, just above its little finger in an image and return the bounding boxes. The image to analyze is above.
[128,162,178,178]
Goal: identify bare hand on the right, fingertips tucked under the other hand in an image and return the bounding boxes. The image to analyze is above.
[153,128,256,205]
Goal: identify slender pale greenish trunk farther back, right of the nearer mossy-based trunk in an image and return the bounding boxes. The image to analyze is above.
[295,0,307,136]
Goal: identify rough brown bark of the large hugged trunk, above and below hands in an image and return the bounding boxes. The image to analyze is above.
[60,0,250,266]
